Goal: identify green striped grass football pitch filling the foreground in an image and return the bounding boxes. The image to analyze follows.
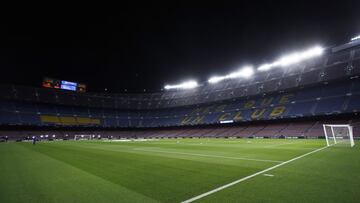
[0,139,360,203]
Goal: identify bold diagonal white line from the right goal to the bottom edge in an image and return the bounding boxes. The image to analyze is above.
[181,146,330,203]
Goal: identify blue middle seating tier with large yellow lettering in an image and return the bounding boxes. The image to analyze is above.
[0,78,360,127]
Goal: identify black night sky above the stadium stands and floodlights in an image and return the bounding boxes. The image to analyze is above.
[0,1,360,92]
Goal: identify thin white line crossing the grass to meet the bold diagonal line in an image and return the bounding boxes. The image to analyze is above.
[133,148,283,163]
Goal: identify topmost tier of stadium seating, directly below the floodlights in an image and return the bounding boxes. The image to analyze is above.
[0,47,360,110]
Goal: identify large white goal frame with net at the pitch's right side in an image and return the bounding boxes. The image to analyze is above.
[323,124,355,147]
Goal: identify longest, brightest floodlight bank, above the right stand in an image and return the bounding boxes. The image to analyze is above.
[258,46,324,71]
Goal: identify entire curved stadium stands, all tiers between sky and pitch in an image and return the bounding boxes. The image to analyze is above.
[0,41,360,140]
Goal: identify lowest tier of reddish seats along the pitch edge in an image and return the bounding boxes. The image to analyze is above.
[0,119,360,139]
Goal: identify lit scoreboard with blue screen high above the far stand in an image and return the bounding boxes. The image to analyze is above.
[42,78,86,92]
